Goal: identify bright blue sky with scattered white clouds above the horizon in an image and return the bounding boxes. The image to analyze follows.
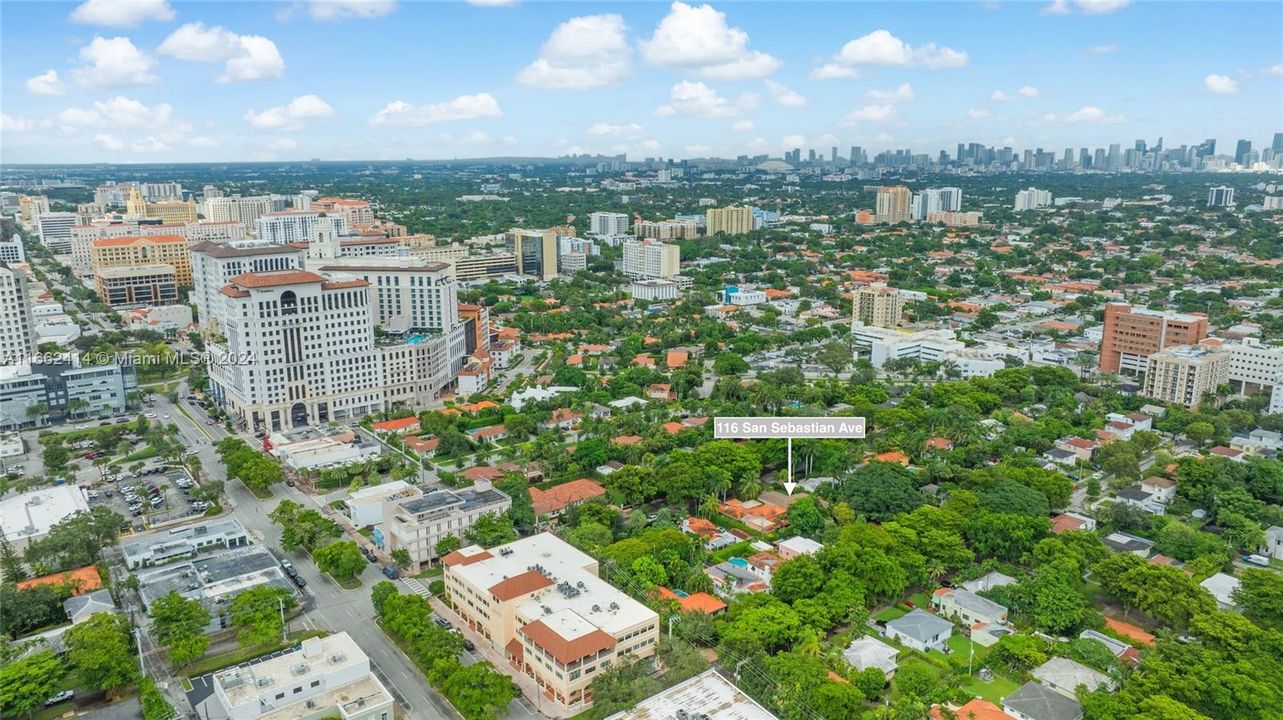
[0,0,1283,163]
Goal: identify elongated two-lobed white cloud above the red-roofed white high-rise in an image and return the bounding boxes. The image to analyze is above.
[157,22,285,83]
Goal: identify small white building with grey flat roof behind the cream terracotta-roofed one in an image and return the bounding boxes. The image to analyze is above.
[375,480,512,572]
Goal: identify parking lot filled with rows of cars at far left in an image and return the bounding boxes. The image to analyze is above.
[86,463,208,530]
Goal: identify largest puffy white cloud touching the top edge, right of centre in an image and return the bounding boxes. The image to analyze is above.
[639,1,783,80]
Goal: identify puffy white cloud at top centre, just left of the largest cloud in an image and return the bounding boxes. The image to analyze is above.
[517,15,633,90]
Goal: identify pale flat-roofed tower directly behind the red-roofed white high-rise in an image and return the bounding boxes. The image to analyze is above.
[190,240,304,338]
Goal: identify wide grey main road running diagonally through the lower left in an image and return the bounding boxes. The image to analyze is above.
[155,391,518,720]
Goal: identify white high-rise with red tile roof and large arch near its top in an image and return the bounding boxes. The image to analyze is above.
[209,270,384,431]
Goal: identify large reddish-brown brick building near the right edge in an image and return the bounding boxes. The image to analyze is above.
[1100,303,1207,375]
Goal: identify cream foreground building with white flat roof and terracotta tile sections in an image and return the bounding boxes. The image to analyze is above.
[441,533,659,712]
